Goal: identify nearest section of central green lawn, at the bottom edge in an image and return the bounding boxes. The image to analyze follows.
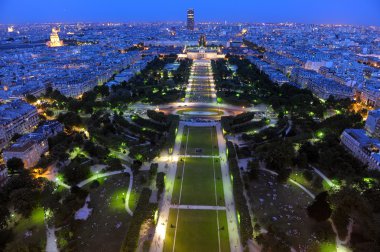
[164,209,230,252]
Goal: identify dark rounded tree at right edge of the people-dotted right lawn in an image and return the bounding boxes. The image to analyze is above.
[307,191,332,222]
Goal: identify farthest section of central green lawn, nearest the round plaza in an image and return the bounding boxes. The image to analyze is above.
[180,127,219,156]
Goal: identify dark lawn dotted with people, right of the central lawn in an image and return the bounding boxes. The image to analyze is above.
[248,172,335,251]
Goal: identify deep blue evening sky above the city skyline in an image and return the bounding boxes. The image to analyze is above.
[0,0,380,26]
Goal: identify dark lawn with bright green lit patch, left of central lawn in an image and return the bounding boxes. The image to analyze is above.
[76,174,134,251]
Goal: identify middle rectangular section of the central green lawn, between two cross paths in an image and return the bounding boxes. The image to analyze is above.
[172,158,225,206]
